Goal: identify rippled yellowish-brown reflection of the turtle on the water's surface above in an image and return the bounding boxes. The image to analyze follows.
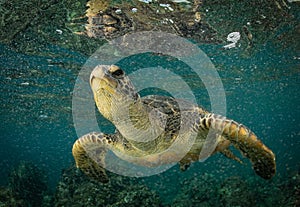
[83,0,217,42]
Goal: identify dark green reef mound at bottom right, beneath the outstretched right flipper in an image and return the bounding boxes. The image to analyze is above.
[170,173,300,207]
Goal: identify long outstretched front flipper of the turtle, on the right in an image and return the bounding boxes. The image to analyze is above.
[201,114,276,179]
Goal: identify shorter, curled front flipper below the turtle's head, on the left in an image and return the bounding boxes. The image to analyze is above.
[72,132,112,183]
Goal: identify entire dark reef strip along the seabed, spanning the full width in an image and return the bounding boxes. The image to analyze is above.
[0,163,300,207]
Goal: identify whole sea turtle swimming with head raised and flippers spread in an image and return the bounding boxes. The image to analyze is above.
[72,65,276,182]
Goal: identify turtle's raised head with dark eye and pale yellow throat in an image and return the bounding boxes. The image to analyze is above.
[90,65,139,121]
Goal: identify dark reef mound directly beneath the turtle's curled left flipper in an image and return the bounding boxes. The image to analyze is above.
[54,167,161,207]
